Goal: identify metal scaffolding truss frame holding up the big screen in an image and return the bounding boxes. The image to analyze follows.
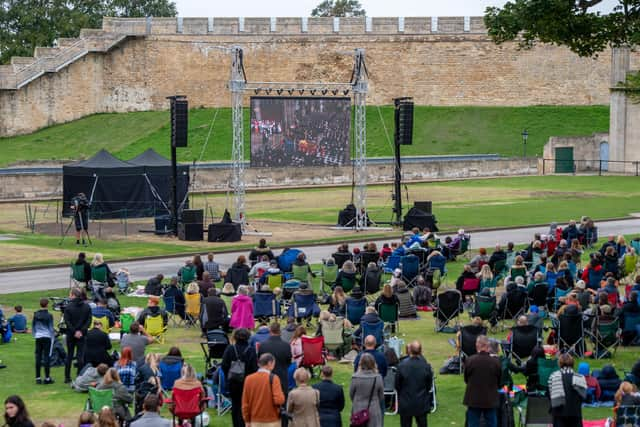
[229,46,368,232]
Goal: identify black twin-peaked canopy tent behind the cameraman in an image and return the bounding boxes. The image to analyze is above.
[62,149,189,218]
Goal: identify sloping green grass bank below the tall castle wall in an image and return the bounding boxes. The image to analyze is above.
[0,106,609,166]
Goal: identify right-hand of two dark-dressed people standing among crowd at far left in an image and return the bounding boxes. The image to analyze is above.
[64,288,91,384]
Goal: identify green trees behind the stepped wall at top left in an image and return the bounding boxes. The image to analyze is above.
[0,0,176,63]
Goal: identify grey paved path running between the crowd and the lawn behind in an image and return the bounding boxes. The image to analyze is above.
[0,218,640,294]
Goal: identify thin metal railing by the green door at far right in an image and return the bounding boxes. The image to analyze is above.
[542,159,640,176]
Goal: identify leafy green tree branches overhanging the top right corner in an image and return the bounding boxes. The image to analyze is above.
[484,0,640,57]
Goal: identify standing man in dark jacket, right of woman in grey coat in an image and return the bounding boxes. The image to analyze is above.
[396,341,433,427]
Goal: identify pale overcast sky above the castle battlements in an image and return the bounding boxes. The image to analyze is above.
[174,0,618,17]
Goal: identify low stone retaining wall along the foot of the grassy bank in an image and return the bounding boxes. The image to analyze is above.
[0,159,538,200]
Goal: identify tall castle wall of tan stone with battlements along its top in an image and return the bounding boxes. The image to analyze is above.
[0,17,640,136]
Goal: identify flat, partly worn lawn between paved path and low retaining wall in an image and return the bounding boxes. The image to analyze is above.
[0,176,640,266]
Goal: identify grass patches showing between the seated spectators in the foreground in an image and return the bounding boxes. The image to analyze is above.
[0,244,638,427]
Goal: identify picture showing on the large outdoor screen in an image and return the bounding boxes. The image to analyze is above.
[251,97,351,167]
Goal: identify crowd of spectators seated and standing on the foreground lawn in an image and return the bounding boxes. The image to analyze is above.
[5,223,640,427]
